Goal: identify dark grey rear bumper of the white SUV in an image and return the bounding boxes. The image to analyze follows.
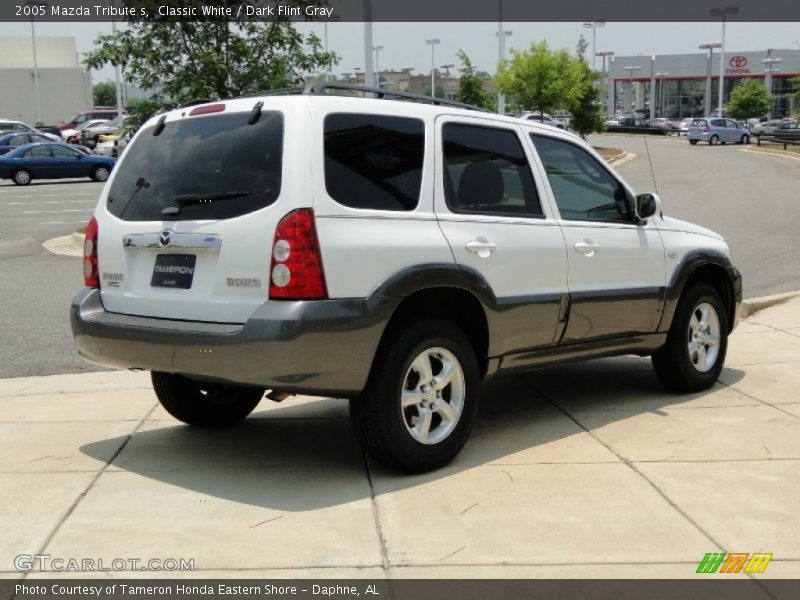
[71,288,397,396]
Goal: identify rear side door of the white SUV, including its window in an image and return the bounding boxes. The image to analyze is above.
[434,116,567,354]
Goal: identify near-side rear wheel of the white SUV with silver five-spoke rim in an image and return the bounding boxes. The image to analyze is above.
[350,320,479,473]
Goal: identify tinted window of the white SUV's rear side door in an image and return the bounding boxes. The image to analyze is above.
[442,123,543,217]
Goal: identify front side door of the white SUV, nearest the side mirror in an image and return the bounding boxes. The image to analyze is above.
[531,134,666,343]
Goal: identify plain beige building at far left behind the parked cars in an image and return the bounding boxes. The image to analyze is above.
[0,36,92,125]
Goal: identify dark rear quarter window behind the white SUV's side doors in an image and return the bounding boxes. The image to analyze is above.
[325,113,425,211]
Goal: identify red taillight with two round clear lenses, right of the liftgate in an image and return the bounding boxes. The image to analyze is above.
[269,208,328,300]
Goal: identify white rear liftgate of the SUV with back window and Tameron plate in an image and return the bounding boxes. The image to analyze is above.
[98,97,311,323]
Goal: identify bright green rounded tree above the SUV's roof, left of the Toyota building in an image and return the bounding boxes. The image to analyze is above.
[495,42,581,115]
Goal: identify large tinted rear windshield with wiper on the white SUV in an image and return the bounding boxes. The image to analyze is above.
[108,111,283,221]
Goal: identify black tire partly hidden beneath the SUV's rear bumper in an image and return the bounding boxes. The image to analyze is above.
[151,371,264,427]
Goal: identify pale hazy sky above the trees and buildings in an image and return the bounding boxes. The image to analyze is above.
[0,22,800,83]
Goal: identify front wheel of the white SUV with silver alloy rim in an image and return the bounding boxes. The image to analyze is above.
[652,283,728,392]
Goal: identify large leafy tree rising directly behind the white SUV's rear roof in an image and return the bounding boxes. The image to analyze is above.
[84,0,337,116]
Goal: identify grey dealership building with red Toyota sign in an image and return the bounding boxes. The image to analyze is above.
[601,49,800,119]
